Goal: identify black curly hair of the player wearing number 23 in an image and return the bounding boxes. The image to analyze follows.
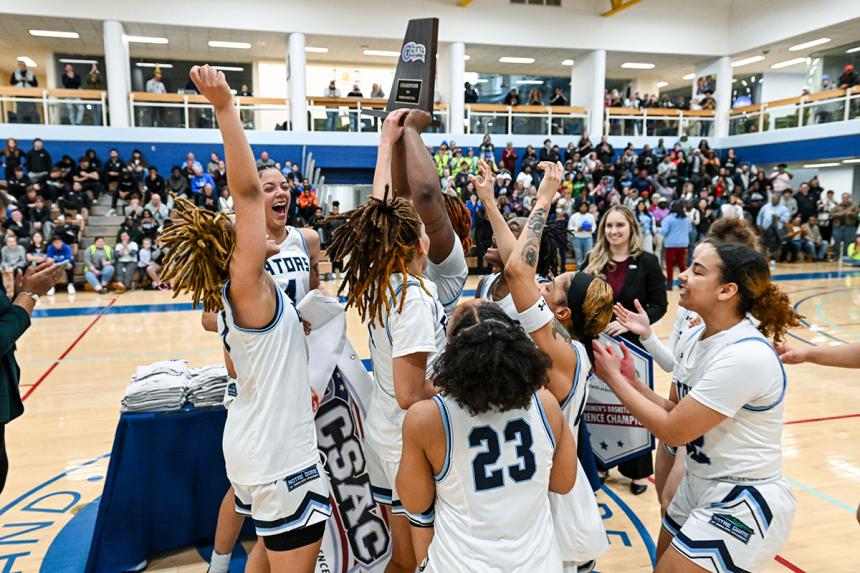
[434,302,552,416]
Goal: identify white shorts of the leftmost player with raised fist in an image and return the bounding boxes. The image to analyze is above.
[233,462,331,536]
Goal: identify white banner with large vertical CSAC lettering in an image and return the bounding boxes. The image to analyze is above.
[298,290,391,573]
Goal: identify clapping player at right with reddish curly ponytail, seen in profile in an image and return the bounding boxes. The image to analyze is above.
[594,242,799,573]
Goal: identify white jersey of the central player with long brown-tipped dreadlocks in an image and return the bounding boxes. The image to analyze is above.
[367,275,447,462]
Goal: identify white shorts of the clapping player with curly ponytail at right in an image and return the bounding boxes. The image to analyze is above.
[663,474,797,573]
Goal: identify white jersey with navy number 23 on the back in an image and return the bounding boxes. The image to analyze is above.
[426,395,562,573]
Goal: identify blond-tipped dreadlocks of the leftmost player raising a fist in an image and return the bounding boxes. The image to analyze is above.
[158,196,236,312]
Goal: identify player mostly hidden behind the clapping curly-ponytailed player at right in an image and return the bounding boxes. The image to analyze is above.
[615,218,758,516]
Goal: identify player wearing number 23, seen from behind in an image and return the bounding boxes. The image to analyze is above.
[397,300,577,573]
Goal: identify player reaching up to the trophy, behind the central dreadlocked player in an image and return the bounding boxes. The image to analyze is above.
[392,109,472,316]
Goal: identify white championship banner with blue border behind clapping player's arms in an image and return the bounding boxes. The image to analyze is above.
[583,334,654,467]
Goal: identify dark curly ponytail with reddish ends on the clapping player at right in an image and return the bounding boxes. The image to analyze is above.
[714,243,803,342]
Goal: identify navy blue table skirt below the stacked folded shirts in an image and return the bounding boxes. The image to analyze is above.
[86,406,253,573]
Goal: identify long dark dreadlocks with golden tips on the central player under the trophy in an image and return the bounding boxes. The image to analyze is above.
[323,185,424,326]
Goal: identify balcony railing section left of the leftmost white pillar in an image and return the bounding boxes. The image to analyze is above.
[0,87,107,125]
